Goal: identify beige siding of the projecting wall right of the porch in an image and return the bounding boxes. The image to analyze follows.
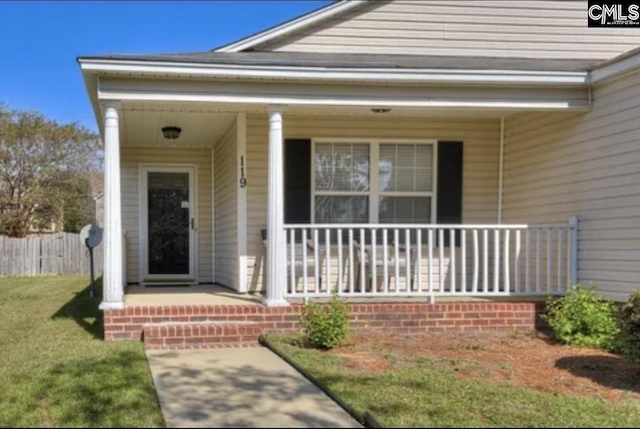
[504,69,640,300]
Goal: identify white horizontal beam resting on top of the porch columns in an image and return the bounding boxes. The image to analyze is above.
[97,78,589,110]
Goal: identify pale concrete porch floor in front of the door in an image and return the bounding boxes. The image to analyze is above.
[124,284,262,307]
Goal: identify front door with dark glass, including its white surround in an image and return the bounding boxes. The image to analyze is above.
[141,166,196,282]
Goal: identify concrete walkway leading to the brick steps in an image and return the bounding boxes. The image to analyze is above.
[147,347,362,428]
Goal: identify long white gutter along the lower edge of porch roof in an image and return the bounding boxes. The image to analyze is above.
[79,59,588,86]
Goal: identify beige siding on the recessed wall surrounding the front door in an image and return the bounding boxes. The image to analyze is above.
[120,146,213,283]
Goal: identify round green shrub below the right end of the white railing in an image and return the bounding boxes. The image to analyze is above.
[542,284,619,348]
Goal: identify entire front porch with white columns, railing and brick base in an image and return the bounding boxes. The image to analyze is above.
[91,73,584,347]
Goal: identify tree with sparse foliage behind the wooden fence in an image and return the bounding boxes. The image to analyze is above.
[0,105,101,237]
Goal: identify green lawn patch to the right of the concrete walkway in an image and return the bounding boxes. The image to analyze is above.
[269,337,640,427]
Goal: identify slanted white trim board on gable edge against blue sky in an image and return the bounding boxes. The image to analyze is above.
[214,0,368,52]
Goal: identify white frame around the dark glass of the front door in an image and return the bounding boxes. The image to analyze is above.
[138,164,198,284]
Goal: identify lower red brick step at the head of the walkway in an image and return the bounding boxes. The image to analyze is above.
[143,321,262,350]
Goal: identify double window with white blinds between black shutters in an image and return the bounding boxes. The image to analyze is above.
[312,141,435,224]
